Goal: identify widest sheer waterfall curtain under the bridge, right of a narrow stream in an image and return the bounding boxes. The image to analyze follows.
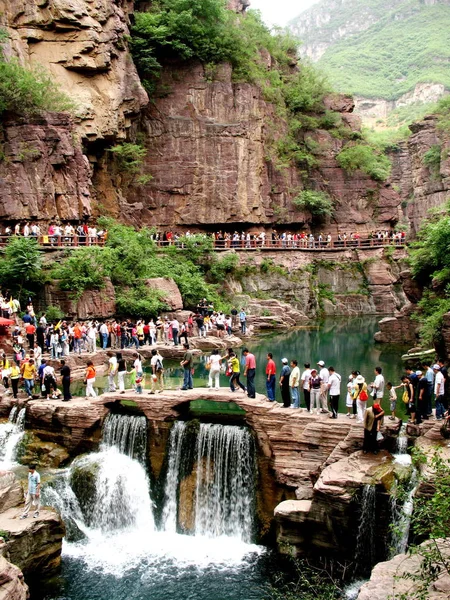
[195,423,255,543]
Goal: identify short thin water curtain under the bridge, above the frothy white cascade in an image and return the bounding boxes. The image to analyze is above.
[102,414,147,464]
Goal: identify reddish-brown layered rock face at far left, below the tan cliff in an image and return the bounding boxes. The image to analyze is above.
[0,113,91,220]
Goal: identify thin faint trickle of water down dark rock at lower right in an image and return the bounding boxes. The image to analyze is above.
[355,484,376,573]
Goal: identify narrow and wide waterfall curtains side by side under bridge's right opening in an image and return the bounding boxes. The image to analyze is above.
[162,421,255,543]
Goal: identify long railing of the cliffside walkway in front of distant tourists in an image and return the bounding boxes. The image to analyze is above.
[0,235,406,252]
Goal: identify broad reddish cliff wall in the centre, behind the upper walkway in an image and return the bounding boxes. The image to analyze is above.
[118,58,399,231]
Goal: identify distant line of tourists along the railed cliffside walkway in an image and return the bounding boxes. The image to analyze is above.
[0,222,406,249]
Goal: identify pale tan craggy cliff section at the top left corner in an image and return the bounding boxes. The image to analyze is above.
[0,0,147,141]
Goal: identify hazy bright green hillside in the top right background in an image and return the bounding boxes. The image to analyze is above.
[292,0,450,100]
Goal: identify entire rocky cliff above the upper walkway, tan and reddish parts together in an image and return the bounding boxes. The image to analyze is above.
[0,0,400,230]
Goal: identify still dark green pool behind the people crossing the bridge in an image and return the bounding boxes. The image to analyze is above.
[72,317,407,417]
